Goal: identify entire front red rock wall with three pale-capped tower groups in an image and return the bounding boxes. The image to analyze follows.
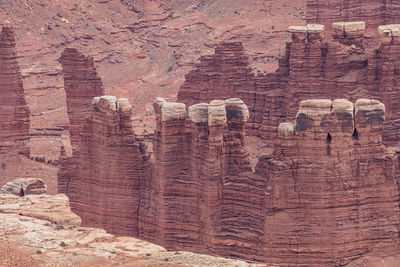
[60,96,400,266]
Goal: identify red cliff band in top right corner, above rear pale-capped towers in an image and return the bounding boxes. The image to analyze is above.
[307,0,400,32]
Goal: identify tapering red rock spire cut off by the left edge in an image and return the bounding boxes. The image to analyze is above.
[0,22,30,157]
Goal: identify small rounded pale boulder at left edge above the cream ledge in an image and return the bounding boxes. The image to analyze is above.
[0,178,47,196]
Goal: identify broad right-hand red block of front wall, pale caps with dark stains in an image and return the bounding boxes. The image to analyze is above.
[257,99,400,266]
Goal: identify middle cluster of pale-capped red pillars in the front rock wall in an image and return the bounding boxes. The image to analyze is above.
[148,98,263,258]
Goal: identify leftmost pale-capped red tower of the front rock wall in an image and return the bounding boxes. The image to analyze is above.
[59,96,151,236]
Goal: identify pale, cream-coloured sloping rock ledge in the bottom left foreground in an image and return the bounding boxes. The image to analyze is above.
[0,191,264,267]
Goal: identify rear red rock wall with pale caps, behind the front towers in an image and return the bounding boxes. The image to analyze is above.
[178,22,400,147]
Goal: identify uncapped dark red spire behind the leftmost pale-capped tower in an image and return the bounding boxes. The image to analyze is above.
[60,48,104,151]
